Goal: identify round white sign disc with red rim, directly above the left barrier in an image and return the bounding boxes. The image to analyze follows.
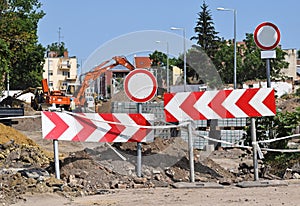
[124,69,157,103]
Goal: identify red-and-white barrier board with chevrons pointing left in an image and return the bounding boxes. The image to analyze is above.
[164,88,276,122]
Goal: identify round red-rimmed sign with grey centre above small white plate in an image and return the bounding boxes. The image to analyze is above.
[253,22,280,50]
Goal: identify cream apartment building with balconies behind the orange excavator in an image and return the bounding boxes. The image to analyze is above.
[43,51,77,91]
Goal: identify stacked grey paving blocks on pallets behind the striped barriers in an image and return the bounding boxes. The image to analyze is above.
[111,102,247,149]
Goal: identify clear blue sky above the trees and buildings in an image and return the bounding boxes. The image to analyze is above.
[38,0,300,72]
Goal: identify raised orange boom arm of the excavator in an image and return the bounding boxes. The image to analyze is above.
[72,56,135,107]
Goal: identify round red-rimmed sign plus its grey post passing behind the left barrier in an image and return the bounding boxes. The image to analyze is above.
[124,69,157,177]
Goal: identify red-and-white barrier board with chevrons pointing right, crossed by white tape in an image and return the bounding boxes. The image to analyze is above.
[42,112,154,142]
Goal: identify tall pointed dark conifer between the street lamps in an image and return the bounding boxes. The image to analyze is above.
[191,1,220,59]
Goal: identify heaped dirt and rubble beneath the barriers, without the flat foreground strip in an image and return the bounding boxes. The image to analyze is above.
[0,97,300,205]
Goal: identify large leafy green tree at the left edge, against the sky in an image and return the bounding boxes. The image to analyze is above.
[0,0,45,89]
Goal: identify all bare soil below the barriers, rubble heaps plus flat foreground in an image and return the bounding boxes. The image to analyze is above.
[0,96,300,206]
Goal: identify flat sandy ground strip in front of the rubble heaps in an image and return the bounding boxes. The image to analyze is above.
[15,183,300,206]
